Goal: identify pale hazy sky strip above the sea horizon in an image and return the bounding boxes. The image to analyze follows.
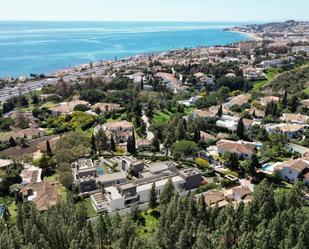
[0,0,309,21]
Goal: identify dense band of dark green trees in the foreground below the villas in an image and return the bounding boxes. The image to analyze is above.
[0,180,309,249]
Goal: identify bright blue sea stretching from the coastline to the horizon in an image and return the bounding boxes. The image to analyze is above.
[0,21,249,78]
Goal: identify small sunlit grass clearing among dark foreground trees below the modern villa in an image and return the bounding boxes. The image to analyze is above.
[139,209,159,237]
